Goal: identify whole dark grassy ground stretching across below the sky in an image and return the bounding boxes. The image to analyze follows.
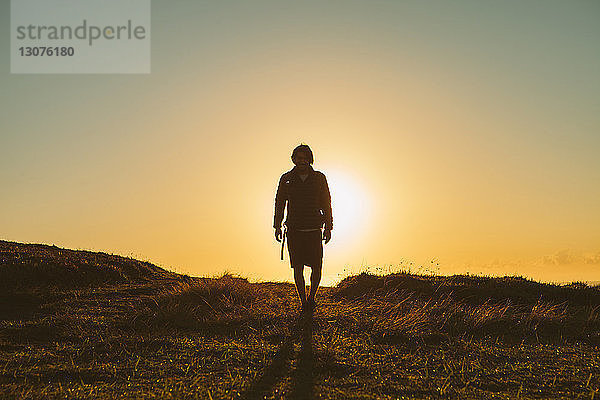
[0,241,600,399]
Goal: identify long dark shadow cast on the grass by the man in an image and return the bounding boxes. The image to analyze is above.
[241,315,314,400]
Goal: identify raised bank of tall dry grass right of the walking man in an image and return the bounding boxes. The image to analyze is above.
[333,274,600,344]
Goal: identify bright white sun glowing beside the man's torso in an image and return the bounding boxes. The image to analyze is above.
[326,170,371,244]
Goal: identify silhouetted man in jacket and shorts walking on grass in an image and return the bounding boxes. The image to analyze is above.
[273,144,333,312]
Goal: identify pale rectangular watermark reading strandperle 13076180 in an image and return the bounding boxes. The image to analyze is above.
[11,0,150,73]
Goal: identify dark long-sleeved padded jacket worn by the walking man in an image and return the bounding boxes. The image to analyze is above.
[273,166,333,229]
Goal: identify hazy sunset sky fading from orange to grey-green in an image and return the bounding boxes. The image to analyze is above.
[0,0,600,285]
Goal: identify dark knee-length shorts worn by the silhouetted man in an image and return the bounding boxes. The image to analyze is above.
[287,229,323,268]
